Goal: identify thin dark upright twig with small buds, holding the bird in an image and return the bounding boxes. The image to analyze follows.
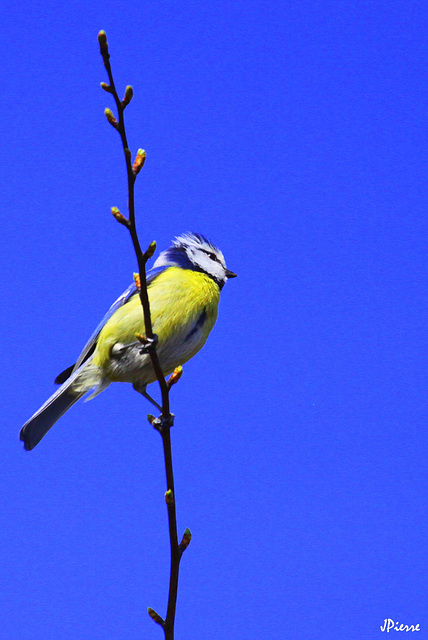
[98,31,191,640]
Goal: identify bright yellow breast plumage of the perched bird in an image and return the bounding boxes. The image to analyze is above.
[92,267,220,379]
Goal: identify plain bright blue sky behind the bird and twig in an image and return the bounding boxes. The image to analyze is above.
[0,0,428,640]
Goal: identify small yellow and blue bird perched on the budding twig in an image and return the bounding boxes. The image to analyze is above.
[20,232,236,451]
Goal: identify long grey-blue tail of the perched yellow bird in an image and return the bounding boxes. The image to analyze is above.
[19,359,108,451]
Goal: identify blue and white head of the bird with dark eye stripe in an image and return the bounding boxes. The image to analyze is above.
[153,233,236,289]
